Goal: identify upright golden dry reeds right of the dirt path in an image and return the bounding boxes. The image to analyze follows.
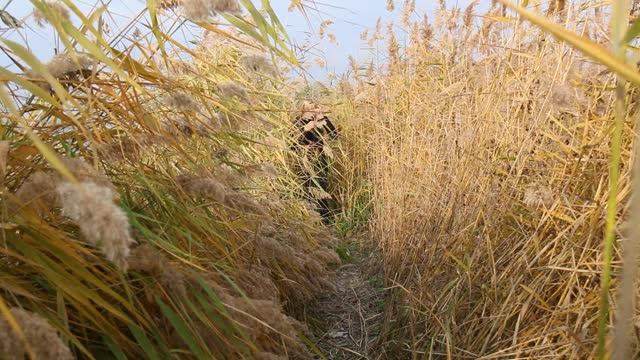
[340,1,637,359]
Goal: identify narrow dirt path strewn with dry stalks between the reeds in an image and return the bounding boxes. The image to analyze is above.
[316,245,384,360]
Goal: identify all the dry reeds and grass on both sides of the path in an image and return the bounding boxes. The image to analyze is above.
[5,0,640,359]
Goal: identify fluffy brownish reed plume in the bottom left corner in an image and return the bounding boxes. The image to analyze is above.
[0,308,73,360]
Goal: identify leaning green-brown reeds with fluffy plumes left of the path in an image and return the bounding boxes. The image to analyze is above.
[0,0,339,359]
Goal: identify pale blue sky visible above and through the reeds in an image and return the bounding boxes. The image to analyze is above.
[0,0,470,77]
